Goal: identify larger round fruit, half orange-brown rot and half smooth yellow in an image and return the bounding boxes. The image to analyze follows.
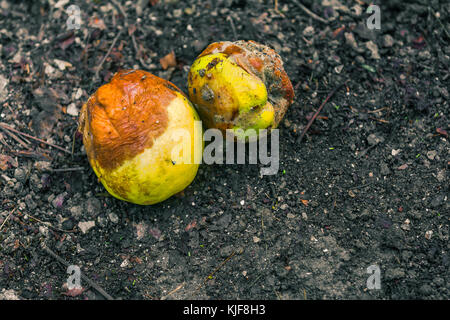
[78,70,203,205]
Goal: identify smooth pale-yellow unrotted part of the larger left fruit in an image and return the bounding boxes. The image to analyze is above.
[90,93,203,205]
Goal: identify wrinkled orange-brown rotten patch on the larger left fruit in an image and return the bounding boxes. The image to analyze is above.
[78,70,182,171]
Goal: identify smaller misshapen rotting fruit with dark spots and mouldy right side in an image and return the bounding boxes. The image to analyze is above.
[188,41,294,140]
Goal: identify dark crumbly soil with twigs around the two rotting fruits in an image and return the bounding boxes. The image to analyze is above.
[0,0,450,299]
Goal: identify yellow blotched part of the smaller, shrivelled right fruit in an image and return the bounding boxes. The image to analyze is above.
[188,53,275,136]
